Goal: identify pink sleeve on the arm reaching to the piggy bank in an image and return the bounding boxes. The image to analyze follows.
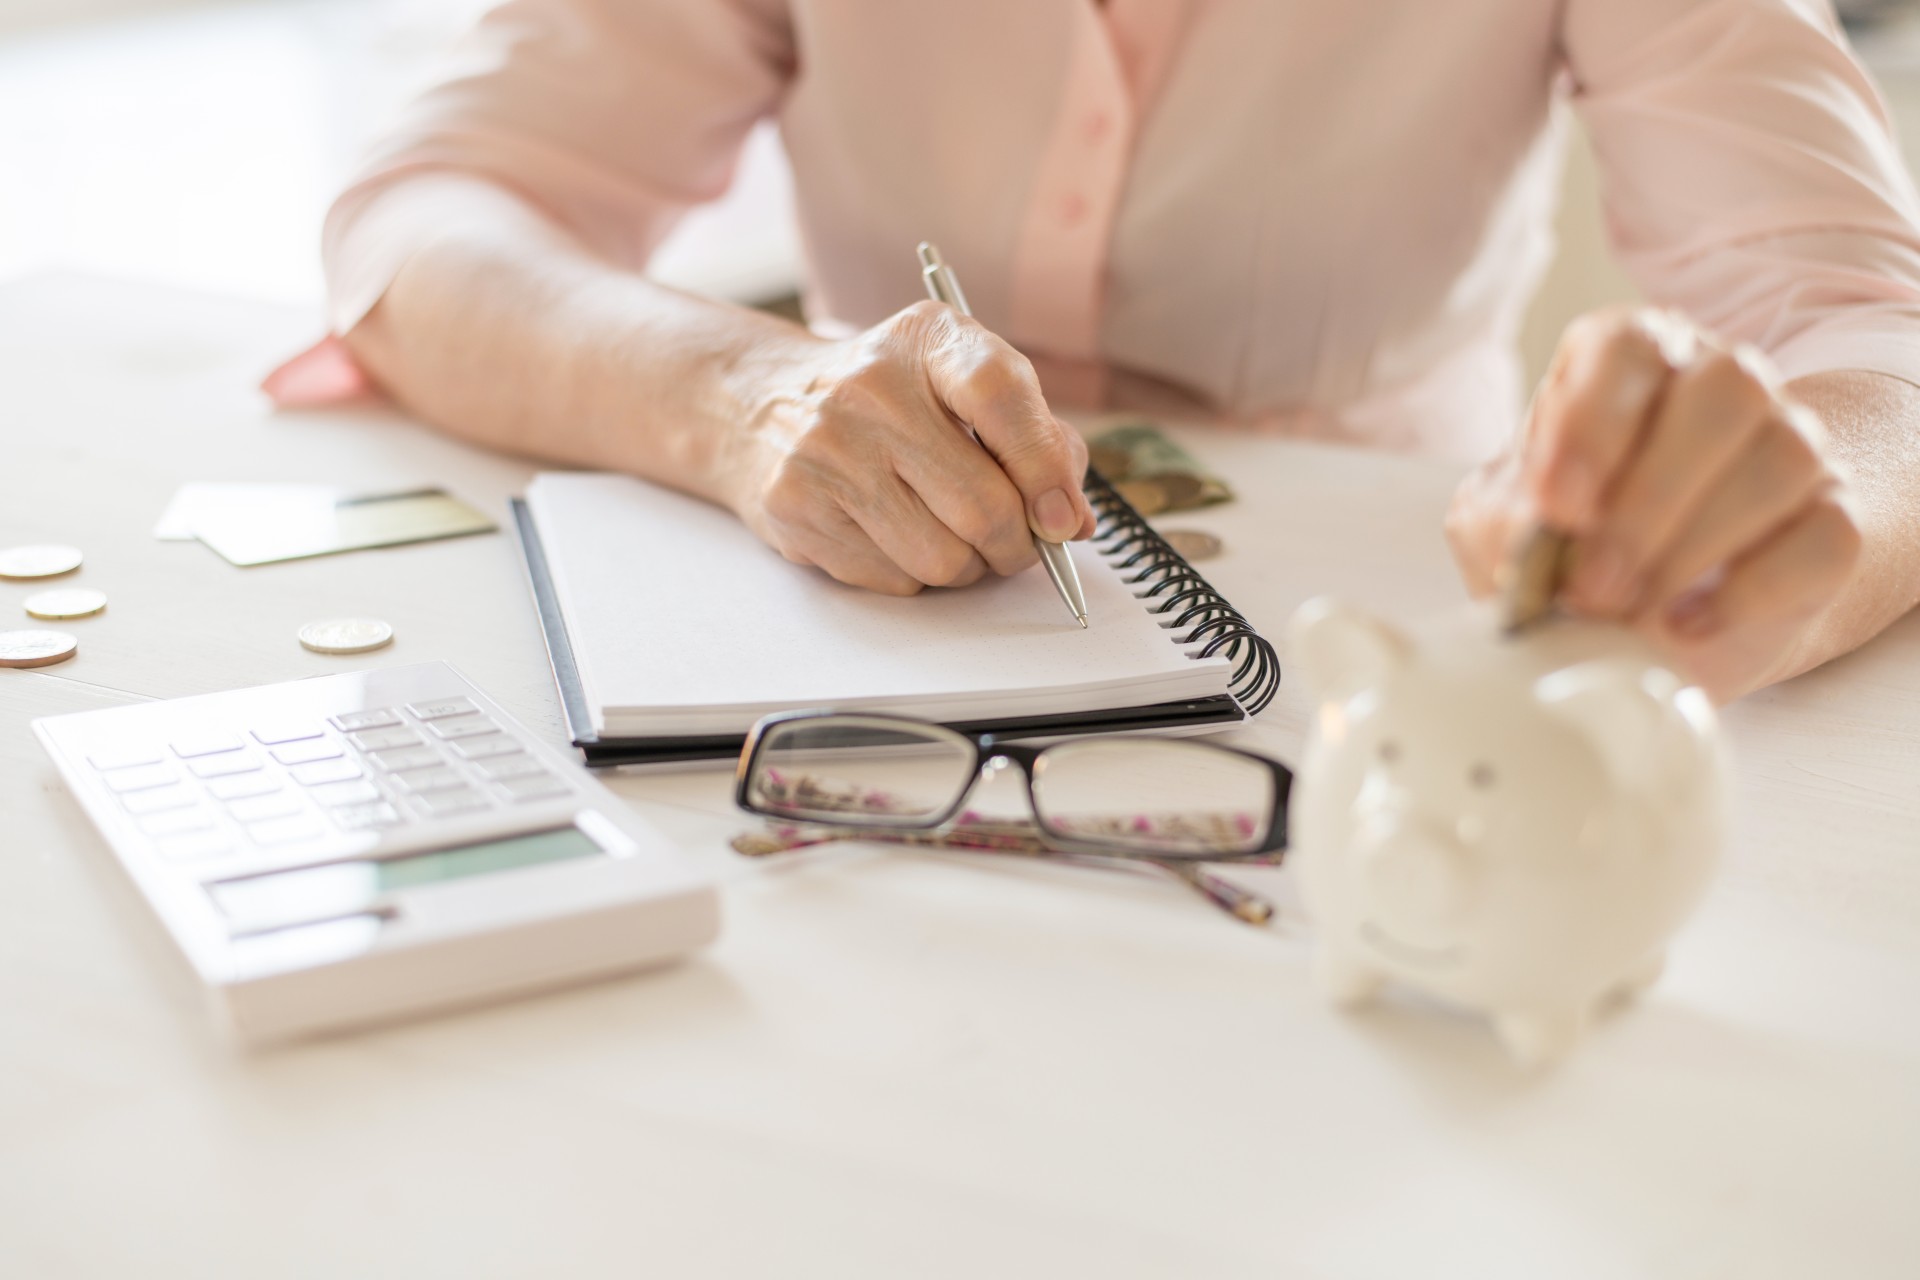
[1563,0,1920,384]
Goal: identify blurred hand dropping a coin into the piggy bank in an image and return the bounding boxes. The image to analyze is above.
[1446,309,1860,700]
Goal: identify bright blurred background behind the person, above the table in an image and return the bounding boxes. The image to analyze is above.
[0,0,1920,385]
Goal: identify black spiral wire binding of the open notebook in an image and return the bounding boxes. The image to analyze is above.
[1085,466,1281,716]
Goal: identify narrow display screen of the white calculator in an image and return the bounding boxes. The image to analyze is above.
[207,825,607,927]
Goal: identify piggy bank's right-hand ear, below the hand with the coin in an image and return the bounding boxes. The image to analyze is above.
[1534,660,1705,789]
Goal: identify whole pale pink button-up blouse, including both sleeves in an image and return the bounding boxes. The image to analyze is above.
[307,0,1920,457]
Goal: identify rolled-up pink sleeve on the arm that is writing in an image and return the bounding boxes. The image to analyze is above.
[323,0,793,332]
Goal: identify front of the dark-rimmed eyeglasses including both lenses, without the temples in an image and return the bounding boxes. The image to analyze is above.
[733,712,1292,862]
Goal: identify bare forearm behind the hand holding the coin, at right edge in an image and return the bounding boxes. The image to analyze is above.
[1772,372,1920,679]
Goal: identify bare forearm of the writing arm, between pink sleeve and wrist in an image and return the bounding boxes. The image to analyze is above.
[346,175,824,503]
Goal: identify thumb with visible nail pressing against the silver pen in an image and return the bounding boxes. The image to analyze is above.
[929,334,1094,543]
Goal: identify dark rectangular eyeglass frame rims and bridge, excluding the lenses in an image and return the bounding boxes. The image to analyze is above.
[733,710,1294,864]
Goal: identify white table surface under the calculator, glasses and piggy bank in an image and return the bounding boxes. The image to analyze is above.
[0,276,1920,1280]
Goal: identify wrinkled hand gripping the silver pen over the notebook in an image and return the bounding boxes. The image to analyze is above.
[730,301,1094,595]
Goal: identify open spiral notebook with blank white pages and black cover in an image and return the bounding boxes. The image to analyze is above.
[513,472,1281,764]
